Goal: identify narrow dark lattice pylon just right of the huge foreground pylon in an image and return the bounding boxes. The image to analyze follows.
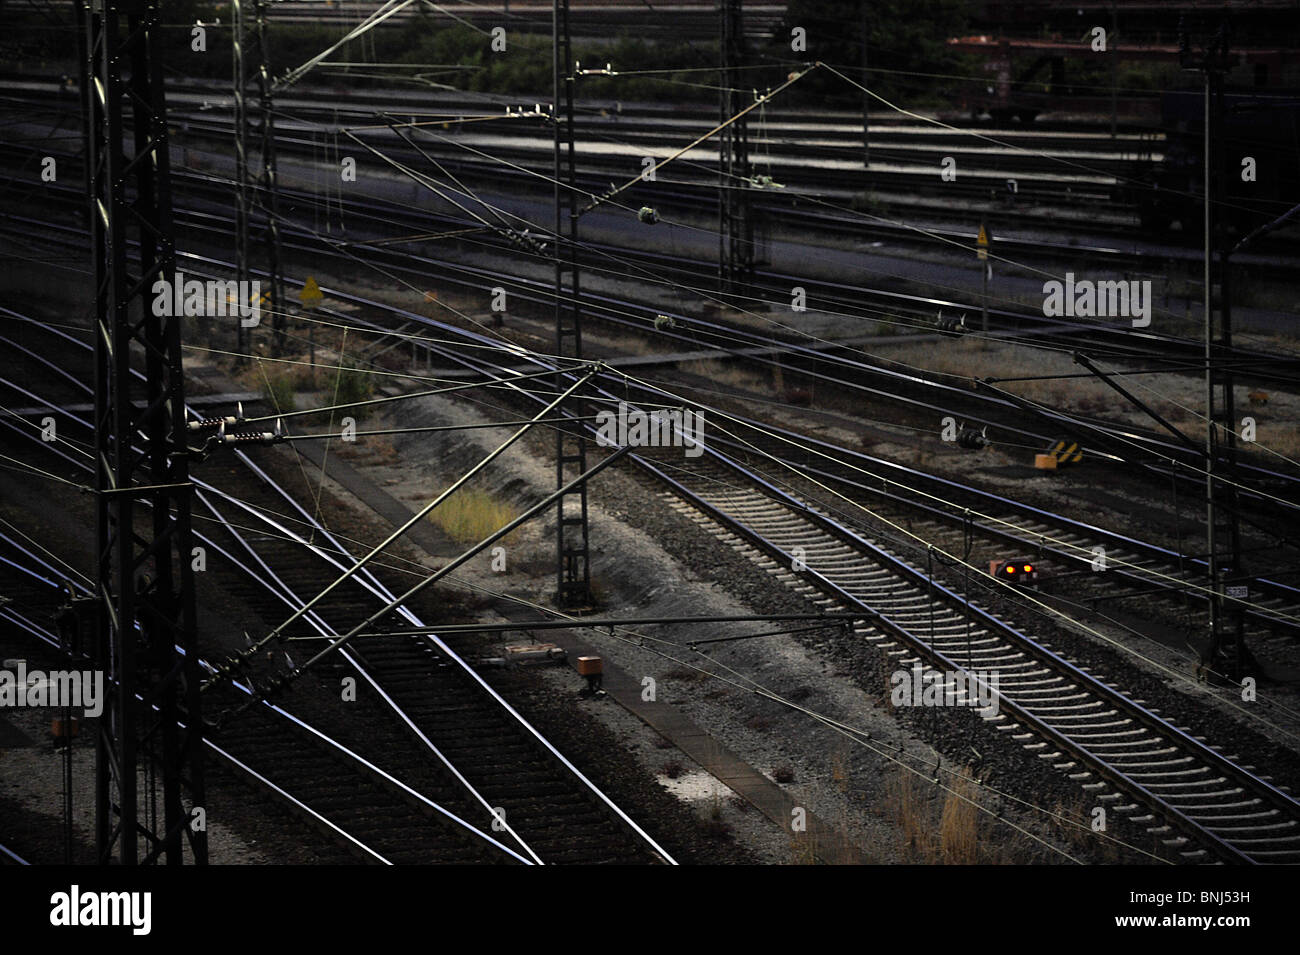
[230,0,289,355]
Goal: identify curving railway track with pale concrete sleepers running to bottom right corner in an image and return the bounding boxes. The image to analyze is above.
[642,455,1300,863]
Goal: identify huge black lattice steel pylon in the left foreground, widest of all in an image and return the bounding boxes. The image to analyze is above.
[78,0,208,865]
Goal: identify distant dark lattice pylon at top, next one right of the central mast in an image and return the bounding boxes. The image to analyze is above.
[718,0,754,294]
